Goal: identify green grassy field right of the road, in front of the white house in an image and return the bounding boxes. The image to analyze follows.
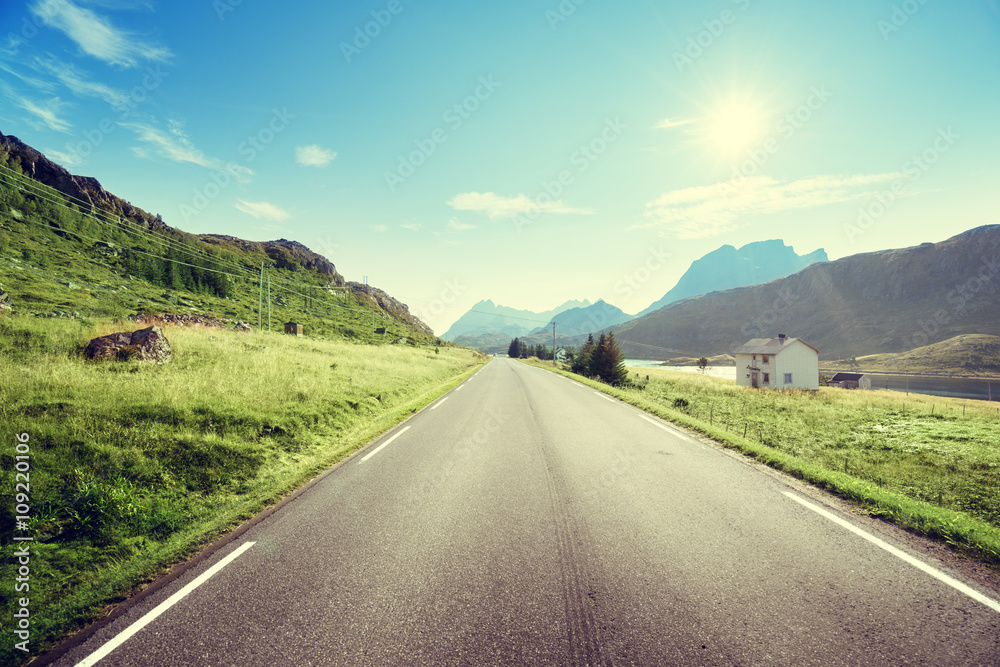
[535,362,1000,567]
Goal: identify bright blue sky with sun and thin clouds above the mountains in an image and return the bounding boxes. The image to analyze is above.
[0,0,1000,334]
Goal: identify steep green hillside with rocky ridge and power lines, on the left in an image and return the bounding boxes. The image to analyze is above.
[0,138,436,344]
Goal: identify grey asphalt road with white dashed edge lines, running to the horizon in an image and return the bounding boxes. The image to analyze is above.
[48,359,1000,667]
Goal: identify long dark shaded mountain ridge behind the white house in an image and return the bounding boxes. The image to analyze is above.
[616,225,1000,359]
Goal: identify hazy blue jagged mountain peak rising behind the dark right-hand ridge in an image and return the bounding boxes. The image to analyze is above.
[638,239,828,317]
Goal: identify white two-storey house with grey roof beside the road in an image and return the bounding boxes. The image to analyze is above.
[733,334,819,390]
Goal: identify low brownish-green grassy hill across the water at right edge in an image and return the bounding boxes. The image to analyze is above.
[829,334,1000,376]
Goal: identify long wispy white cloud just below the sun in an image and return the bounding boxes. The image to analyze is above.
[637,172,904,238]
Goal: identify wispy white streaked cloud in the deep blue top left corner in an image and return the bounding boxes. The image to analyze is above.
[31,0,173,67]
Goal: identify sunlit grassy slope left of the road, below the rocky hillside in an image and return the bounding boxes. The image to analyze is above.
[0,317,485,665]
